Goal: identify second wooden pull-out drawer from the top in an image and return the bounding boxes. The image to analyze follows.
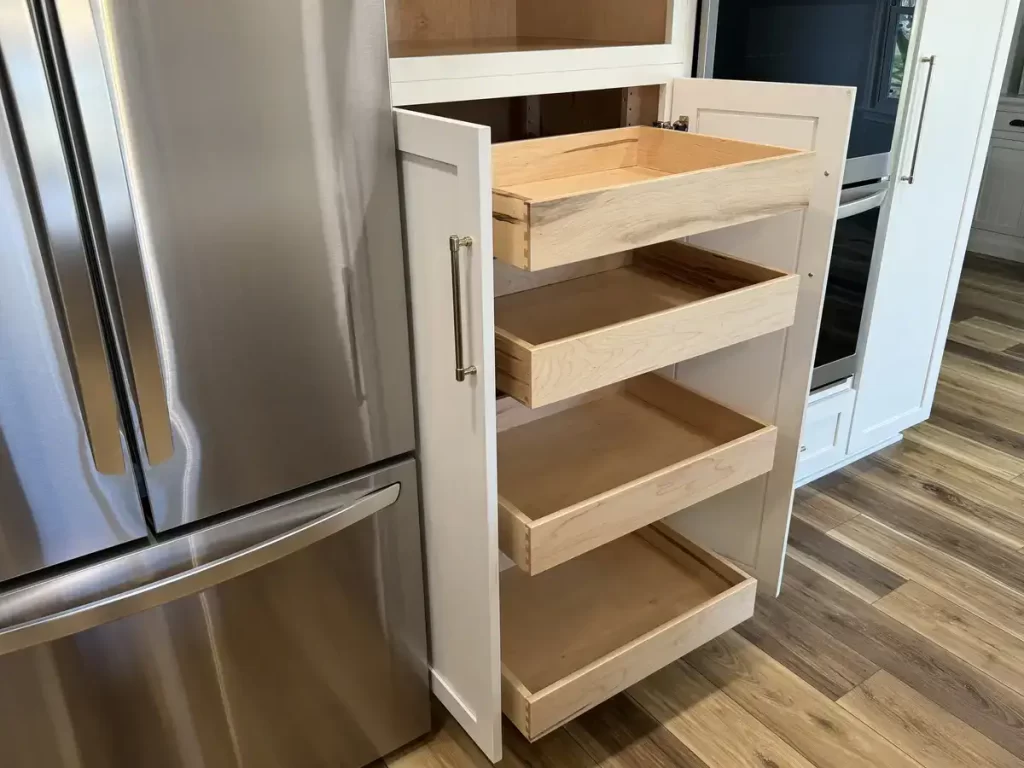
[495,243,800,408]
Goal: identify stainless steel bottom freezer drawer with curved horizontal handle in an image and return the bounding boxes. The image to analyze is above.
[0,461,429,768]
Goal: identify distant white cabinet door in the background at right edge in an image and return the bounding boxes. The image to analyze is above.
[974,137,1024,237]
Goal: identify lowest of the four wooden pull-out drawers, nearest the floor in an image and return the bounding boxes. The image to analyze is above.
[501,524,757,740]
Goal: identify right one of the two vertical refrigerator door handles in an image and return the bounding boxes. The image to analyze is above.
[36,0,174,466]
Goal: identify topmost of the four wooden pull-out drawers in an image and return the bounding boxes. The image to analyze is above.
[492,127,815,270]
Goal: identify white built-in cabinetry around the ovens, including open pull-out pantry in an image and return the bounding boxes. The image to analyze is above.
[388,0,1018,760]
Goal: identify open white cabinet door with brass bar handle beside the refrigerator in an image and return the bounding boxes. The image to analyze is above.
[395,110,502,762]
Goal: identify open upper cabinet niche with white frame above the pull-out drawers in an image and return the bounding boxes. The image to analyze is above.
[387,0,694,106]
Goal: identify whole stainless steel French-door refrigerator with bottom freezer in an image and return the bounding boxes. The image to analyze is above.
[0,0,428,768]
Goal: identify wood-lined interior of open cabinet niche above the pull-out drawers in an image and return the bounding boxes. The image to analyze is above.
[387,0,672,58]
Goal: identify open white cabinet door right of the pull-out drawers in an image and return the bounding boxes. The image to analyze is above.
[671,79,854,594]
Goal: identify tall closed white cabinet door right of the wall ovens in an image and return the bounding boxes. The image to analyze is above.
[849,0,1018,454]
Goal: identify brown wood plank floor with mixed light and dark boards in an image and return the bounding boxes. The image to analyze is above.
[387,255,1024,768]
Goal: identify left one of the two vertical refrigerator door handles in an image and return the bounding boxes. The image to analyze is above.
[0,3,125,475]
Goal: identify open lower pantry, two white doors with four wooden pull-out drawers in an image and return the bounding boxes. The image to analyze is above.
[396,73,853,760]
